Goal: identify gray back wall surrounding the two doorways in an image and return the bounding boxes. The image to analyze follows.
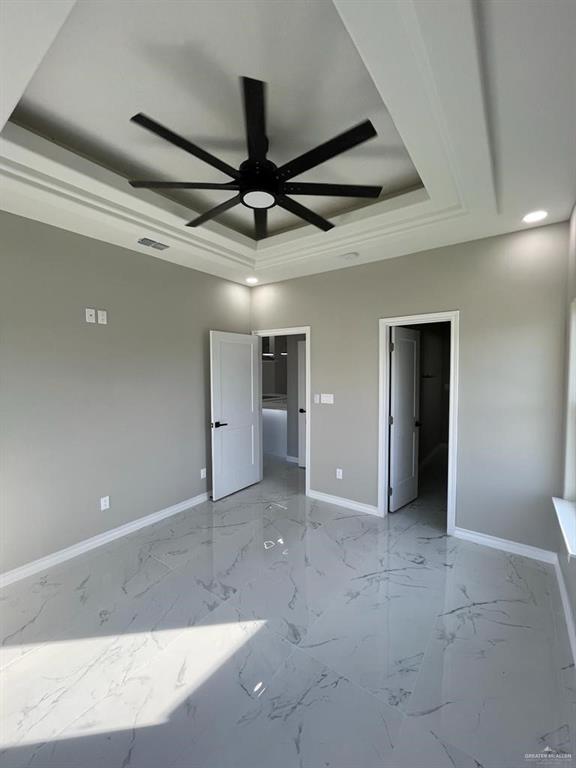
[252,224,568,549]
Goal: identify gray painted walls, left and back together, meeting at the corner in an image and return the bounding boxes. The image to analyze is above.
[0,207,576,584]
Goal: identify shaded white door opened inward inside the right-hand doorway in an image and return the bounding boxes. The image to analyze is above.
[388,326,420,512]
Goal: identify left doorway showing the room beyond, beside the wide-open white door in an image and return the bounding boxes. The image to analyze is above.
[253,328,310,493]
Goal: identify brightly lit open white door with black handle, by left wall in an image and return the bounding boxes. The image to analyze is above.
[210,331,262,500]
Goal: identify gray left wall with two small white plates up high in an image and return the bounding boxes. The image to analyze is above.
[0,213,250,571]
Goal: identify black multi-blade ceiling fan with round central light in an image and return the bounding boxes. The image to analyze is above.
[130,77,382,240]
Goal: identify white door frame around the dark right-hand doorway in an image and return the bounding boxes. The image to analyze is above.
[378,310,460,535]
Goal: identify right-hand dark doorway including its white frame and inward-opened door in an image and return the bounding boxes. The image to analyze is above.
[378,312,458,533]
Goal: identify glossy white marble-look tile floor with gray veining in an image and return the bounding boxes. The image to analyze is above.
[1,462,576,768]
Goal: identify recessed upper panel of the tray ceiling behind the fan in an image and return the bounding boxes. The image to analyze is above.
[12,0,420,234]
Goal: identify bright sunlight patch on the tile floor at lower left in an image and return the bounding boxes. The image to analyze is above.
[0,620,266,748]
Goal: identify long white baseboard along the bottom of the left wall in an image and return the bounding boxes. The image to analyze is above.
[0,493,208,589]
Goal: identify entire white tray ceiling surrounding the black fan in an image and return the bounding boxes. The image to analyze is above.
[0,0,576,282]
